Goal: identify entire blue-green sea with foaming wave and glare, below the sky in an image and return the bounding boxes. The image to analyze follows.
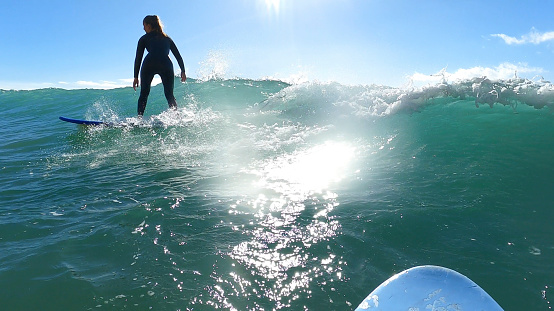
[0,79,554,310]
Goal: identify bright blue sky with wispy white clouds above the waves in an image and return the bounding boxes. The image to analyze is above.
[0,0,554,89]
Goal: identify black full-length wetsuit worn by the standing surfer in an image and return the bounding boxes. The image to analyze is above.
[135,32,185,115]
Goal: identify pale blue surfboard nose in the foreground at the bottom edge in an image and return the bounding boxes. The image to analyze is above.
[355,266,503,311]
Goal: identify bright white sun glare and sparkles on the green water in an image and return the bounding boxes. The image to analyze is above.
[220,142,354,309]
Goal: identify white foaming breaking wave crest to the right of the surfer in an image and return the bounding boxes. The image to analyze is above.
[261,77,554,117]
